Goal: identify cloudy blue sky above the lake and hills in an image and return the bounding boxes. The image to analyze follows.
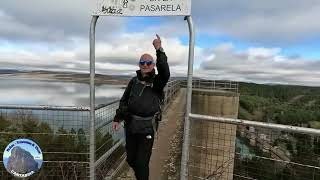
[0,0,320,86]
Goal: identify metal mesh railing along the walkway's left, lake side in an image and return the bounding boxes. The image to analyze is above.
[0,81,180,180]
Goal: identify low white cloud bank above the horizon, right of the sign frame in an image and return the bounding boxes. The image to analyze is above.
[196,45,320,86]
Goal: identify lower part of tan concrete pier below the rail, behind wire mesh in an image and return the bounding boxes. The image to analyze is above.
[188,120,236,179]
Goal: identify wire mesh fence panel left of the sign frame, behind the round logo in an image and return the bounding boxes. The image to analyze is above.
[0,106,89,179]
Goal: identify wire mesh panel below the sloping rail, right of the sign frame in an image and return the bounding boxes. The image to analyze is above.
[188,119,320,180]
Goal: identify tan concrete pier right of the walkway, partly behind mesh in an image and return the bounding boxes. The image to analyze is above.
[189,89,239,180]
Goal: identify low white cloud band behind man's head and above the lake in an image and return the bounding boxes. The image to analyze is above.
[0,33,192,74]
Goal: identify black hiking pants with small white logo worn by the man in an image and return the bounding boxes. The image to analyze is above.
[126,133,154,180]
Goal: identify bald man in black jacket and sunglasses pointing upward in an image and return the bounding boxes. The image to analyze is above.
[112,35,170,180]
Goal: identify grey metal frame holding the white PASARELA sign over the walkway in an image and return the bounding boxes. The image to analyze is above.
[90,0,195,180]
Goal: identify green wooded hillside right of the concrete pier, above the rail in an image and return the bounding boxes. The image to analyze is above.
[239,83,320,128]
